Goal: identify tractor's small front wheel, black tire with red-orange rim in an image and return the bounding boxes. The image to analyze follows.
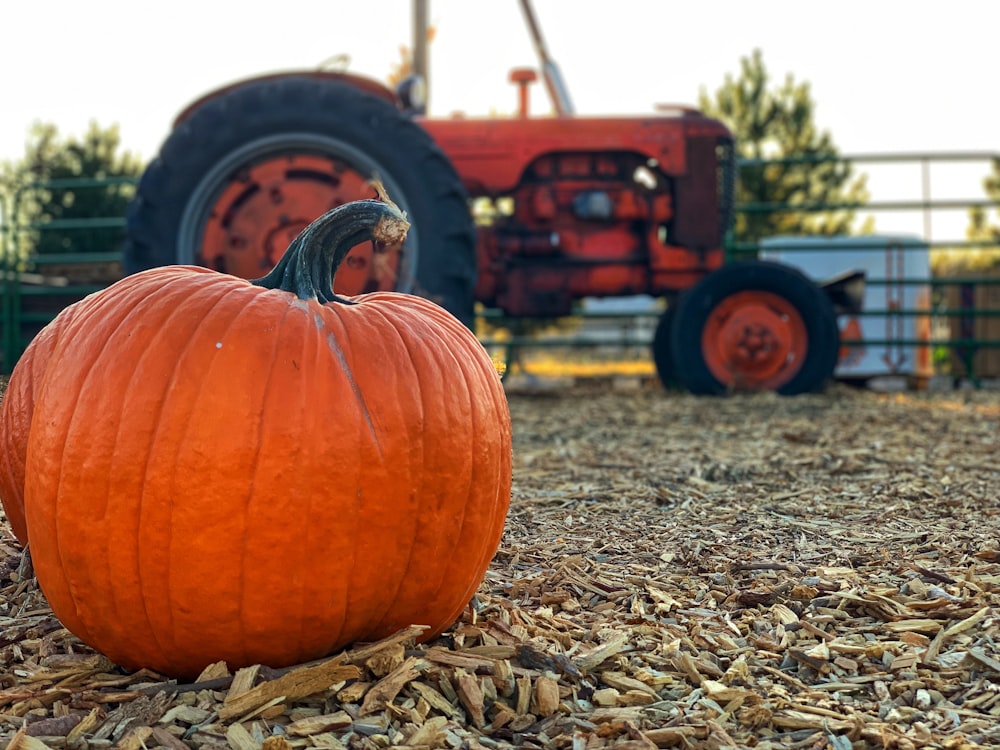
[670,261,839,395]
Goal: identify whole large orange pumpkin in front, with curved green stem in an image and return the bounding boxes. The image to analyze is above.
[24,200,511,677]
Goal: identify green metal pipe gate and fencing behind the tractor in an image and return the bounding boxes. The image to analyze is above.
[0,153,1000,384]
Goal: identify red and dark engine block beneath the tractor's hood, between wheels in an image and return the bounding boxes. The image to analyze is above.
[477,152,673,317]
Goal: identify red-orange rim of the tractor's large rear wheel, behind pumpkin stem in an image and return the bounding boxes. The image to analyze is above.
[197,154,399,295]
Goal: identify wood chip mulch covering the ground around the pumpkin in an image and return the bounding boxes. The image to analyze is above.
[0,384,1000,750]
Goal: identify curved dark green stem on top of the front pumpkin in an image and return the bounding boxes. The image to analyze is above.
[250,200,410,305]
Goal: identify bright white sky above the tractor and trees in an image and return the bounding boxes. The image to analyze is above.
[0,0,1000,239]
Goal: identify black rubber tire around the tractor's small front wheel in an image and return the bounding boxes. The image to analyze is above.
[670,260,840,396]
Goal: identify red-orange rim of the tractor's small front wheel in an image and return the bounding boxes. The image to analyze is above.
[701,290,809,391]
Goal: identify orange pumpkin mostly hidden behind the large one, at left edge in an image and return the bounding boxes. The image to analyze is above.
[0,300,86,546]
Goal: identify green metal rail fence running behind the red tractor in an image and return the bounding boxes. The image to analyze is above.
[0,153,1000,383]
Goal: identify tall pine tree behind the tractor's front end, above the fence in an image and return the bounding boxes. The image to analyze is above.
[699,50,868,250]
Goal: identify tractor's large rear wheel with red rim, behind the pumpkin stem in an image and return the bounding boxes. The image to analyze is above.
[124,75,476,327]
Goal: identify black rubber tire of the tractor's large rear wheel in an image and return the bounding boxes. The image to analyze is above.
[124,75,476,328]
